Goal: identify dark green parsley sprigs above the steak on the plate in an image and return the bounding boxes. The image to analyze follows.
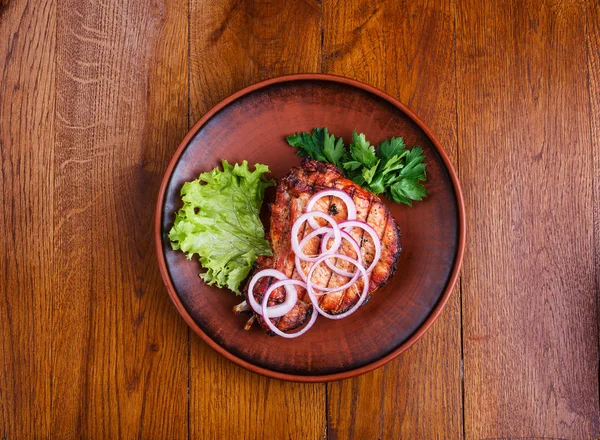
[286,128,427,206]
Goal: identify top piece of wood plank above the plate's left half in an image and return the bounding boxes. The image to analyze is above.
[190,0,321,117]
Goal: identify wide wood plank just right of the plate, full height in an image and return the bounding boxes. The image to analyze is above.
[457,0,600,439]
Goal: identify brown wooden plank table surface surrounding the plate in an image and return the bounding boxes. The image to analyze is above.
[0,0,600,440]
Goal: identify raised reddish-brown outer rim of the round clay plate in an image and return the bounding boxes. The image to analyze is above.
[154,73,466,383]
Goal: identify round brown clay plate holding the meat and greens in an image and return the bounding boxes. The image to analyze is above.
[155,74,465,382]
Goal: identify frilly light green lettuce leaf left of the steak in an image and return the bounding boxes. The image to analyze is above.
[169,160,275,295]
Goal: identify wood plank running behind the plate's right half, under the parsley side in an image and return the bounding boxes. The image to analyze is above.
[323,0,462,439]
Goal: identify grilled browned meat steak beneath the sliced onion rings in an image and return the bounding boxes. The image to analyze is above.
[245,158,401,331]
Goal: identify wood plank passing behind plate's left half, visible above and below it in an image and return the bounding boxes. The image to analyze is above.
[190,0,326,439]
